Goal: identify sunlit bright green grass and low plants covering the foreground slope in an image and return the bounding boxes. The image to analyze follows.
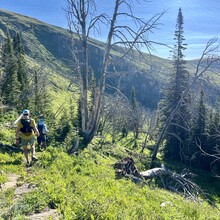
[0,146,220,220]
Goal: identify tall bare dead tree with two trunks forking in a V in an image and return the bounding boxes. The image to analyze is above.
[65,0,164,144]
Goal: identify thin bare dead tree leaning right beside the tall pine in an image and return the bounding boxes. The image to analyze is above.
[152,38,220,163]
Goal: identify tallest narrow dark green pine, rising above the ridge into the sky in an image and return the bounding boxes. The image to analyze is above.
[160,8,190,160]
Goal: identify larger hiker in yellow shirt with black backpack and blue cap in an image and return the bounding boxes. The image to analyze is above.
[16,109,39,165]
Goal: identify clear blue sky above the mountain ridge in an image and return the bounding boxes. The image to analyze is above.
[0,0,220,59]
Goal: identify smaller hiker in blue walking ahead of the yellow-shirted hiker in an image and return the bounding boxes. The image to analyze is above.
[37,115,49,151]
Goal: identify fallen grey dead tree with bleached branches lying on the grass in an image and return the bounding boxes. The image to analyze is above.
[114,157,207,202]
